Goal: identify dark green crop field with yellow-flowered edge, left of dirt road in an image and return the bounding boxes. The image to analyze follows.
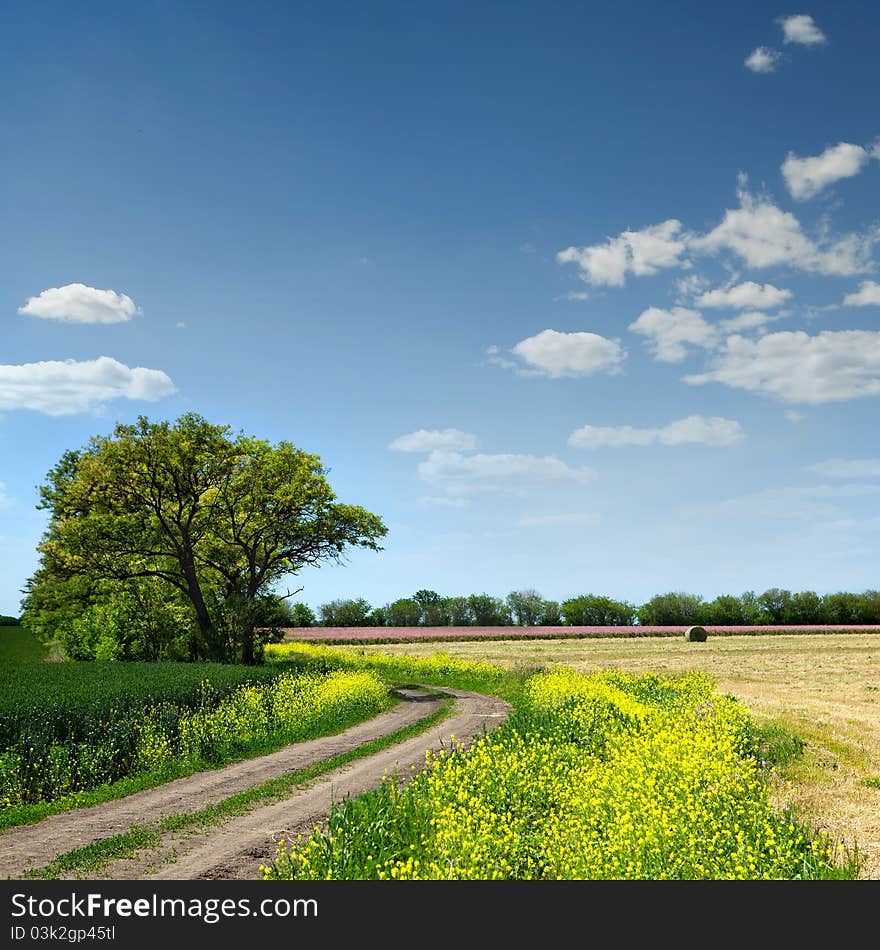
[0,628,395,827]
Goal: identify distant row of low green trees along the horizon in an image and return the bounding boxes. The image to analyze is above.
[289,587,880,627]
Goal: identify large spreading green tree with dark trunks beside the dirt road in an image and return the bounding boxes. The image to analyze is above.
[36,413,387,664]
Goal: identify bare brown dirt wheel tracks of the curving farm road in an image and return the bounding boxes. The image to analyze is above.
[0,689,510,880]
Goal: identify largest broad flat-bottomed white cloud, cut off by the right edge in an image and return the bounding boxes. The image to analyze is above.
[684,330,880,406]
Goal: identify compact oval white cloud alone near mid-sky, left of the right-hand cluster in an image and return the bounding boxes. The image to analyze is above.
[506,330,626,379]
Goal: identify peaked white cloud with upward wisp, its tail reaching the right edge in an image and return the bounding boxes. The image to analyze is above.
[689,187,880,277]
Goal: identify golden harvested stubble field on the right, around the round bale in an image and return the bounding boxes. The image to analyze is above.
[357,633,880,880]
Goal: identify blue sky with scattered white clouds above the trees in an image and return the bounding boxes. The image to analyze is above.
[0,0,880,614]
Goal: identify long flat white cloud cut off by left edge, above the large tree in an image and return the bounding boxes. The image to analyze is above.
[0,356,176,416]
